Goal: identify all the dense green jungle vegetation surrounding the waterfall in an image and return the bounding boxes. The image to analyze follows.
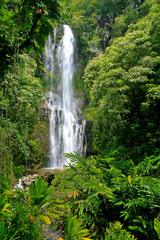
[0,0,160,240]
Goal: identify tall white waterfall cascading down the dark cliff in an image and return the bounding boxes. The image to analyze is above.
[45,25,85,169]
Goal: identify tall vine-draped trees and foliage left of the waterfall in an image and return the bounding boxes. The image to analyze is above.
[0,0,61,189]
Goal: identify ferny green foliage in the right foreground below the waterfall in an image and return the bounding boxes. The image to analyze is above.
[52,153,160,240]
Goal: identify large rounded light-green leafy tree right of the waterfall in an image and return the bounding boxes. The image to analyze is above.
[85,1,160,159]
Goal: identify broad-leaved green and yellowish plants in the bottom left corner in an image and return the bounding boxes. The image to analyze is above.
[0,178,63,240]
